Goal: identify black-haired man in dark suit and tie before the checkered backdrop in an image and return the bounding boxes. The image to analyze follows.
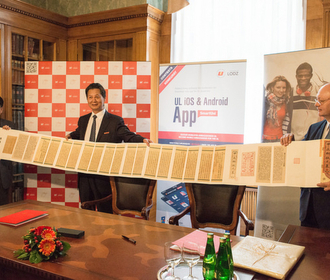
[66,83,151,213]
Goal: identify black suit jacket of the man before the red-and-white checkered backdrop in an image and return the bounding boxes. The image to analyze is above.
[70,111,144,143]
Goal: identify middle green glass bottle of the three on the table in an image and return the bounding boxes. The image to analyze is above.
[215,237,231,280]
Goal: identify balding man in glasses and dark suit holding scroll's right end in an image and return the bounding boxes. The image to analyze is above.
[281,84,330,229]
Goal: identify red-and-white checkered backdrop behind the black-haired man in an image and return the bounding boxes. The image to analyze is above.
[23,61,151,207]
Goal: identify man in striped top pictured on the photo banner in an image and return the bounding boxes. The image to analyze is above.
[288,62,324,140]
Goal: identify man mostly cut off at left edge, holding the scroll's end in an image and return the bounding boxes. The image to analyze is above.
[0,97,14,205]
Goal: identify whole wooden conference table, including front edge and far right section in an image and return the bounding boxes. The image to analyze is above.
[0,200,330,280]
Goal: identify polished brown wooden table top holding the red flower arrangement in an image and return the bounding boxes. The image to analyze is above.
[0,200,253,280]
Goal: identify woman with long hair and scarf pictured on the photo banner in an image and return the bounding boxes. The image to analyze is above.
[262,76,291,142]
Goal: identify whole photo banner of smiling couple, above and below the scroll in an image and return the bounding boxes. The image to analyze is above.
[255,48,330,240]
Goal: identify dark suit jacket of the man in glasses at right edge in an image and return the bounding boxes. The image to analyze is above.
[300,120,330,229]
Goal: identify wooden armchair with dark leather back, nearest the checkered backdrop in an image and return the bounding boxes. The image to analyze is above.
[81,177,156,220]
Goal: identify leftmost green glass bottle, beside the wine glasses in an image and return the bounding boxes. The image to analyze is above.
[203,233,216,280]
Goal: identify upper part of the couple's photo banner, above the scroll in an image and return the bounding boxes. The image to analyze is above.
[262,48,330,142]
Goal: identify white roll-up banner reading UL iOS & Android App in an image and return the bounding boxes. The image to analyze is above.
[156,60,246,226]
